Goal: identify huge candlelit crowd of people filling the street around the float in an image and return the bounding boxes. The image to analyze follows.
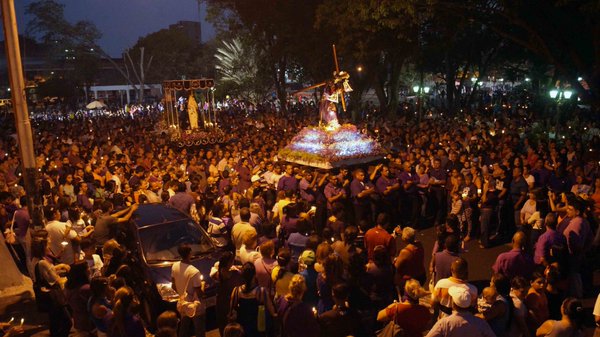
[0,102,600,337]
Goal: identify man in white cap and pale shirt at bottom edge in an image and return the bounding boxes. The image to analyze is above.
[426,286,496,337]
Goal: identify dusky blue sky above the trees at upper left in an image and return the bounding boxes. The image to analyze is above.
[15,0,215,57]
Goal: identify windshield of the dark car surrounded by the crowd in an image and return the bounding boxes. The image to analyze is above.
[139,221,214,263]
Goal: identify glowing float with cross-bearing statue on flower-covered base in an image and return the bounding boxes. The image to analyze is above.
[277,46,385,169]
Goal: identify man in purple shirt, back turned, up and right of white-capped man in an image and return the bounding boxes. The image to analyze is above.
[492,231,535,280]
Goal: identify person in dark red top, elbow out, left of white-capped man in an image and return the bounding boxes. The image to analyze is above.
[377,279,431,337]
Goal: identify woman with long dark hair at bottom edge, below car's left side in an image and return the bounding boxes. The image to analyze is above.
[108,287,146,337]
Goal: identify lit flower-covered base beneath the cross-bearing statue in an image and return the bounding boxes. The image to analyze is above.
[278,124,385,169]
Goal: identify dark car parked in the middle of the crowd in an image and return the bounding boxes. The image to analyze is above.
[119,204,223,326]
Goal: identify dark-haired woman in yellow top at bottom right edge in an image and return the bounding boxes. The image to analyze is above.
[535,297,585,337]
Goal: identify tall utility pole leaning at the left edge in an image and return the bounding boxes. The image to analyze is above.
[0,0,42,226]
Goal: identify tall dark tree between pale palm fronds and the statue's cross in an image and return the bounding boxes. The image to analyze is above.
[207,0,331,112]
